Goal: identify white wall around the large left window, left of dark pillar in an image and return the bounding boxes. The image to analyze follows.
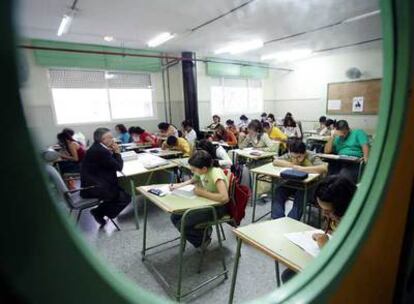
[20,51,184,148]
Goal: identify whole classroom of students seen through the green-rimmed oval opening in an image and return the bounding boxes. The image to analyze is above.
[4,0,414,304]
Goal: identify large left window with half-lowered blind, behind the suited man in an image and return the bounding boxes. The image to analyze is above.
[49,69,154,125]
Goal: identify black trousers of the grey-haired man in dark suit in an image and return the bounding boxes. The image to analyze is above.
[81,186,131,218]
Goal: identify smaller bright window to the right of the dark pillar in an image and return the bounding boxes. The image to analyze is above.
[211,79,263,115]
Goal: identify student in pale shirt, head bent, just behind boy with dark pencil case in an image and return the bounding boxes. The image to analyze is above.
[239,119,277,152]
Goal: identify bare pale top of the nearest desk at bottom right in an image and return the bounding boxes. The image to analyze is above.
[233,217,315,271]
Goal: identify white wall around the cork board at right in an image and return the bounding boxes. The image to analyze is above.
[267,43,382,133]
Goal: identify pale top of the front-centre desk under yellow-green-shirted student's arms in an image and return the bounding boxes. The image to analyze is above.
[137,185,220,213]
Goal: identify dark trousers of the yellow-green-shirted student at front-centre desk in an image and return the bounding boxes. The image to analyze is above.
[171,205,227,248]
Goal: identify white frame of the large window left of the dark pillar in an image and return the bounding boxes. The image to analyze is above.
[47,67,158,127]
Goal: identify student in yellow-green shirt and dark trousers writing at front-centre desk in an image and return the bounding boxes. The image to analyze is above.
[170,150,229,250]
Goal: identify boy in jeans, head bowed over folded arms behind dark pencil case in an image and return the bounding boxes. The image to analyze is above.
[271,140,328,220]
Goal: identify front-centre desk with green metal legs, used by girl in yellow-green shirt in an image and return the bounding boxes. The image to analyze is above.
[136,185,228,301]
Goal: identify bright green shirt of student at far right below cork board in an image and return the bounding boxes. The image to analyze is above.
[332,129,369,157]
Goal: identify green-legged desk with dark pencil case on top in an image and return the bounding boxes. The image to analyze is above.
[250,163,320,223]
